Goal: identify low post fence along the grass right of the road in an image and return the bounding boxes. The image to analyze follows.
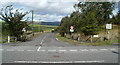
[64,34,117,42]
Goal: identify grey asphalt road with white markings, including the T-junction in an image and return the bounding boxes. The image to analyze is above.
[0,33,118,63]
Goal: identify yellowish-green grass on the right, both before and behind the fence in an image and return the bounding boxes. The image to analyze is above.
[56,25,120,46]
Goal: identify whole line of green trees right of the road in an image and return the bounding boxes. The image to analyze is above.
[58,2,120,36]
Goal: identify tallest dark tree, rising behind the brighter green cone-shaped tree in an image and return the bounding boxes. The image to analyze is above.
[74,2,114,26]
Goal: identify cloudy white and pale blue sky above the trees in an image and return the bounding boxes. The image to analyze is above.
[0,0,118,22]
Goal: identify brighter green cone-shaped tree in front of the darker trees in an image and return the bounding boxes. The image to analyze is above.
[81,10,99,35]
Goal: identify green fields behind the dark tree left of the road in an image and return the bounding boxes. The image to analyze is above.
[0,22,57,43]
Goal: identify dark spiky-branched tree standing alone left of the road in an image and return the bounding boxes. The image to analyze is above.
[0,5,28,41]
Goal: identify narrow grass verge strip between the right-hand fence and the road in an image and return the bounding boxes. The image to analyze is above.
[55,33,118,46]
